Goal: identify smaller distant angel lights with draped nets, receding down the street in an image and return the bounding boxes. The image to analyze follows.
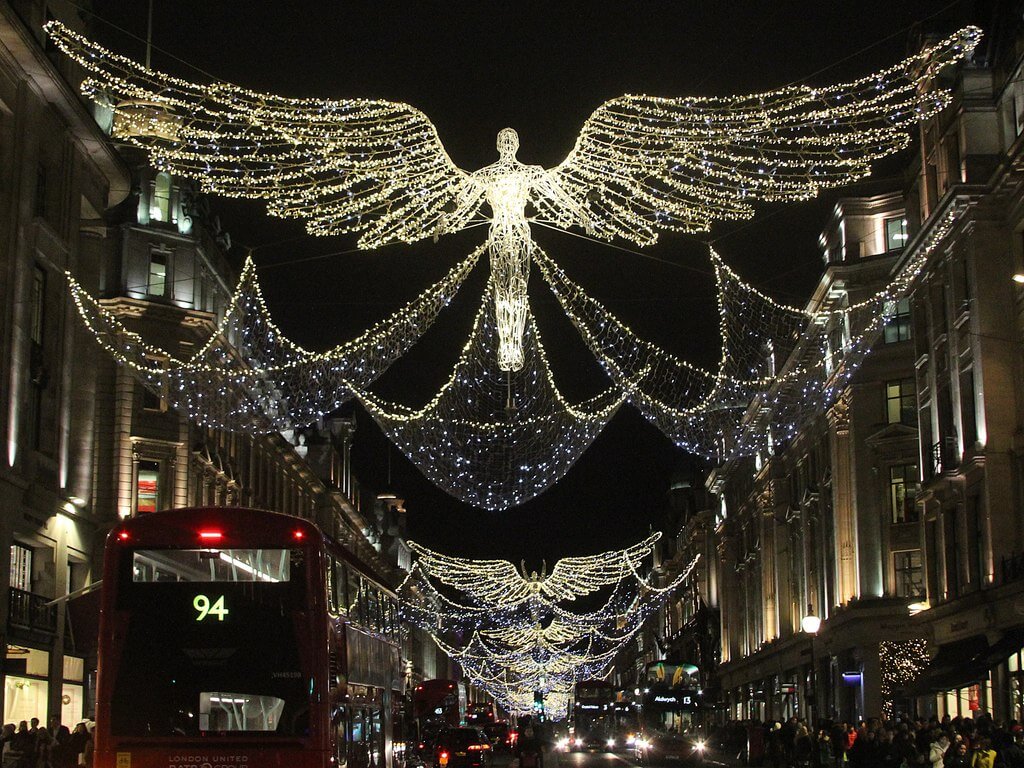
[398,534,697,719]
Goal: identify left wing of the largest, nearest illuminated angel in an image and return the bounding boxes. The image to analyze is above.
[46,22,481,248]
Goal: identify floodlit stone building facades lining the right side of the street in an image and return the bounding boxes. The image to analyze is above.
[659,3,1024,721]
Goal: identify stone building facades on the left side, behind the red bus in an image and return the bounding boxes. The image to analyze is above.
[0,0,458,725]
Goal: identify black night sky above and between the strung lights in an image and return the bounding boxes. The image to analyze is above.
[86,0,974,562]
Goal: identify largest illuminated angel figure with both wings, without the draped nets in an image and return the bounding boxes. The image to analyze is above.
[47,22,980,371]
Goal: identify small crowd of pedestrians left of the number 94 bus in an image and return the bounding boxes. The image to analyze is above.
[0,718,92,768]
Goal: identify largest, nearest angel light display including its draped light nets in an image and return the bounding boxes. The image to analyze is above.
[46,22,980,510]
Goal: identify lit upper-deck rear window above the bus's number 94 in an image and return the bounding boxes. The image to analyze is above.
[132,549,291,584]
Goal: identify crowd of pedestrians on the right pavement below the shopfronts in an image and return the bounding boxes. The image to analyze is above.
[714,714,1024,768]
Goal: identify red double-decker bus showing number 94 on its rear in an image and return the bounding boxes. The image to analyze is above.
[94,508,400,768]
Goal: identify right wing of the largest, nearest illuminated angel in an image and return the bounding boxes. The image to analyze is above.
[535,27,981,245]
